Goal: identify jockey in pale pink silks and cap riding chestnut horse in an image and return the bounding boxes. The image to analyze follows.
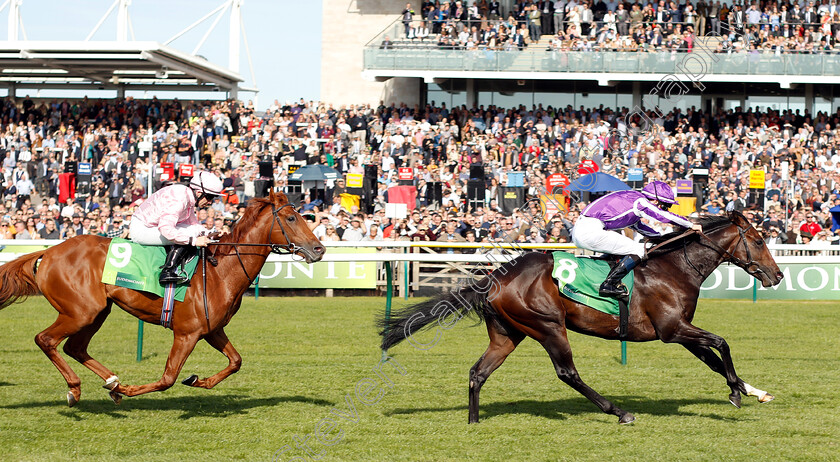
[130,172,223,285]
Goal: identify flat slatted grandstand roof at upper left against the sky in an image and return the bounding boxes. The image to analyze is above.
[0,41,244,93]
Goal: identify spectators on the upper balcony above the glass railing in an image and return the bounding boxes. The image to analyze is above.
[388,0,840,54]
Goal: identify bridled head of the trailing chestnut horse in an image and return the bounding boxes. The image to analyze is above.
[268,191,326,263]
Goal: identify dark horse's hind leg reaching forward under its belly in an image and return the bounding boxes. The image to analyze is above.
[541,326,636,424]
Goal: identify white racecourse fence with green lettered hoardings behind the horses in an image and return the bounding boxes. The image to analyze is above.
[0,240,840,300]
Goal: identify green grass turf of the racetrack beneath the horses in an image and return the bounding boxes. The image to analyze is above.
[0,297,840,461]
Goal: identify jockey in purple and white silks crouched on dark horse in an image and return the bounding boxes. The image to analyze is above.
[572,181,703,297]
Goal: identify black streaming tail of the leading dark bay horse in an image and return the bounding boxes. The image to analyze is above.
[377,280,495,350]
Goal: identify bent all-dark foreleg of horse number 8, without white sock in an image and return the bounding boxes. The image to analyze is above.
[662,322,747,407]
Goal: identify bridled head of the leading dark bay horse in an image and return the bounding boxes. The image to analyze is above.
[724,212,784,287]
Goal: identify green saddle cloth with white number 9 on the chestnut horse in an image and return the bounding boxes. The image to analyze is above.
[102,238,198,302]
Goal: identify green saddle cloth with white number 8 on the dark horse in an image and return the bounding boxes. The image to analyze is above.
[551,252,633,316]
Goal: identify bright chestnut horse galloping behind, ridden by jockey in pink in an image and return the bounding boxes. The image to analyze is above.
[0,192,324,406]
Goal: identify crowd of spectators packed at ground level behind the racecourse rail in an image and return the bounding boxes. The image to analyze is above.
[0,93,840,249]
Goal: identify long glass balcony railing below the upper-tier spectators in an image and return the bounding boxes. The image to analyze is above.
[364,46,840,76]
